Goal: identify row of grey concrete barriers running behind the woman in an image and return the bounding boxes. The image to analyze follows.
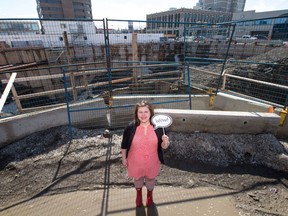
[0,94,288,147]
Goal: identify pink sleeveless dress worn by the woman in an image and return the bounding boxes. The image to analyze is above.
[127,125,160,180]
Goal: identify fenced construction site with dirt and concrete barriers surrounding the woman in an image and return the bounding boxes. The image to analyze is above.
[0,17,288,216]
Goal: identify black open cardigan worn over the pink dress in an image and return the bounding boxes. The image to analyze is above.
[121,122,166,164]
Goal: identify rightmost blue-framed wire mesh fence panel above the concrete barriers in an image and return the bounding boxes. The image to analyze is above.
[184,17,288,109]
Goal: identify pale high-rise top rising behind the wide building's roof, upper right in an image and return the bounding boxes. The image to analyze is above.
[198,0,246,13]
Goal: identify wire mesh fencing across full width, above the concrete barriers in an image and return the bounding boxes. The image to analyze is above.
[0,17,288,122]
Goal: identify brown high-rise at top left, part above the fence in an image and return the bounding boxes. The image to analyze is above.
[36,0,92,19]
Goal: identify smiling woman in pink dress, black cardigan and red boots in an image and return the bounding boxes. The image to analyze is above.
[121,101,169,207]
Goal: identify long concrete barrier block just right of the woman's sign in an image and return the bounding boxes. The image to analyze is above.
[157,109,280,135]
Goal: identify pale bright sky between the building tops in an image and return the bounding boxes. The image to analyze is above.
[0,0,288,20]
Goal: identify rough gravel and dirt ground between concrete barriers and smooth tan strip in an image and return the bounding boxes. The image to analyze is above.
[0,127,288,216]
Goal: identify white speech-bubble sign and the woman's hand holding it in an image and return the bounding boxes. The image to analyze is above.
[151,114,172,149]
